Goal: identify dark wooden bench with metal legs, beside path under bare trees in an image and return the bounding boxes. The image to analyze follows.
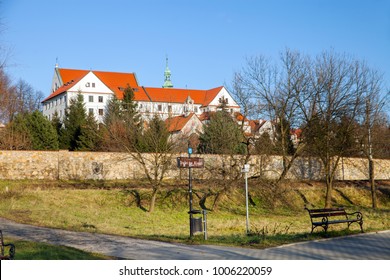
[305,207,363,233]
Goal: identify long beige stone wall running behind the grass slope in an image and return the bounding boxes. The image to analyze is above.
[0,151,390,180]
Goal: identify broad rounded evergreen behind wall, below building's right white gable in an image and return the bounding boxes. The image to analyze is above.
[199,111,246,154]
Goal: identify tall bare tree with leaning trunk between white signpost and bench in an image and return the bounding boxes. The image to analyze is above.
[233,49,309,182]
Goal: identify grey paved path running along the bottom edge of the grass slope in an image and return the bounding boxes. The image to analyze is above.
[0,218,390,260]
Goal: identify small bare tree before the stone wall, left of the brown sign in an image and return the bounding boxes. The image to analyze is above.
[102,87,177,212]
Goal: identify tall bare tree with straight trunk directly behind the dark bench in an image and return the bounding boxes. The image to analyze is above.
[304,52,366,207]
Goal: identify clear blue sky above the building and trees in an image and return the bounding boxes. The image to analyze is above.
[0,0,390,95]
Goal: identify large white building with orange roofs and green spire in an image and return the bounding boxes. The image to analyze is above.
[42,66,240,122]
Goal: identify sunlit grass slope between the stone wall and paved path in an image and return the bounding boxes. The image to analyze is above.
[0,181,390,254]
